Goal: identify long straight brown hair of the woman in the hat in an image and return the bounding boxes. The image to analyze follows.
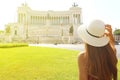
[85,43,117,80]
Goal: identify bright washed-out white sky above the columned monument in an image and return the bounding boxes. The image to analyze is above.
[0,0,120,29]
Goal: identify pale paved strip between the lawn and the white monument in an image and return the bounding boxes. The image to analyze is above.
[29,44,120,58]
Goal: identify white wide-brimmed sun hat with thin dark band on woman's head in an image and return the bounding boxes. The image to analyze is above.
[78,20,109,47]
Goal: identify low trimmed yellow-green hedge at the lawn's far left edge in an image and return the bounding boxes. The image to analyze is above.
[0,43,28,48]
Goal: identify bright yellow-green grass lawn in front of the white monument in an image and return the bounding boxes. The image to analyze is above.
[0,47,120,80]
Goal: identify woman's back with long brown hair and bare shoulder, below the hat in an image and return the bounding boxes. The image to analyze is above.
[78,44,117,80]
